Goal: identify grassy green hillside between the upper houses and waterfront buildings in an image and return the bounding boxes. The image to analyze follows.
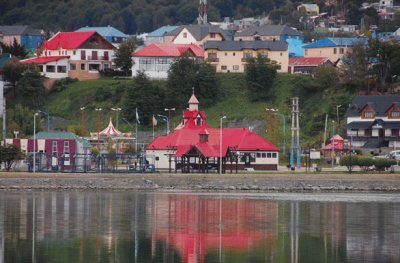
[44,74,352,152]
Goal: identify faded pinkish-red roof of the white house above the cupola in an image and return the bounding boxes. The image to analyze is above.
[131,43,204,57]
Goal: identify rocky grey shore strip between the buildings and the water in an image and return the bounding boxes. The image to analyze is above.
[0,172,400,193]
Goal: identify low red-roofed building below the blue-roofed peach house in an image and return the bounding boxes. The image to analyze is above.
[288,57,334,75]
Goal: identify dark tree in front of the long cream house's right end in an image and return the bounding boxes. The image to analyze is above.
[245,54,277,101]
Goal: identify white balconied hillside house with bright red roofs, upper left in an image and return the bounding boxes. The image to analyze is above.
[21,31,115,79]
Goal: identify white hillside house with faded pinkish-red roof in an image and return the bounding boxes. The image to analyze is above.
[132,43,204,79]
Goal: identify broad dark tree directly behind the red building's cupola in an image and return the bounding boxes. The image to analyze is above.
[166,54,219,108]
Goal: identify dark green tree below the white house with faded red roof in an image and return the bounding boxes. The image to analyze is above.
[122,72,163,125]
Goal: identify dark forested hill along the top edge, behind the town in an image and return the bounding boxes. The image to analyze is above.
[0,0,286,34]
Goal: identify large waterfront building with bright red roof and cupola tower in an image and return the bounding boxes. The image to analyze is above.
[146,94,279,172]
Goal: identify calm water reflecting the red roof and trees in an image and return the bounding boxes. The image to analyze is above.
[0,192,400,263]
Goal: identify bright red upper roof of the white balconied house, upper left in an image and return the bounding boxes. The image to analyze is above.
[42,31,114,50]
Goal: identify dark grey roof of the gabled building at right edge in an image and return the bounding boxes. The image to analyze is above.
[345,95,400,117]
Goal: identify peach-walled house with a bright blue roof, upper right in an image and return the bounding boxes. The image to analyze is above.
[303,37,368,63]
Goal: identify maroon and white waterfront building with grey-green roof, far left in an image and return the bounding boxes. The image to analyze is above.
[6,131,92,171]
